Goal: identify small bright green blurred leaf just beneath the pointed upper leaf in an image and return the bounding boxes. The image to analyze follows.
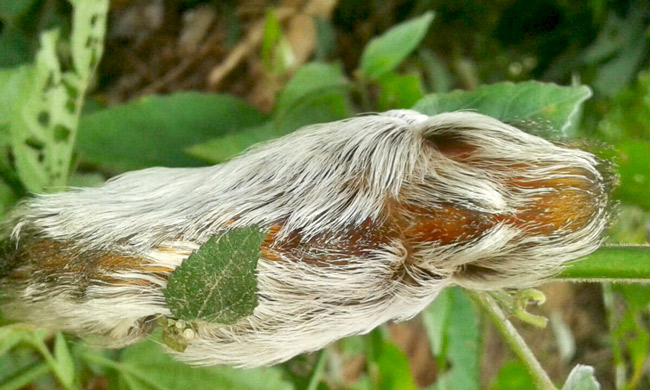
[377,72,424,111]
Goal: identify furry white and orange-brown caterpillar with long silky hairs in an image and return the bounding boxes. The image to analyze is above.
[0,110,608,367]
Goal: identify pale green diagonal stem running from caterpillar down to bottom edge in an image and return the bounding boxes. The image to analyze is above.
[468,291,557,390]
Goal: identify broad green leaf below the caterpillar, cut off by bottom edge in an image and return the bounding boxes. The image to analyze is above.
[109,341,293,390]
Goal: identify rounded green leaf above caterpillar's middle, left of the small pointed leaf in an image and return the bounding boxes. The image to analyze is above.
[274,62,350,120]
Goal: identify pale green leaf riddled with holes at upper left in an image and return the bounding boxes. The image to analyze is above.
[9,0,108,192]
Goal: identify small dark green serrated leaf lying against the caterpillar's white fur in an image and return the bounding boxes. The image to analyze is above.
[165,226,266,324]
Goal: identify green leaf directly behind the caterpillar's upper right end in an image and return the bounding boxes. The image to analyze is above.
[413,81,591,137]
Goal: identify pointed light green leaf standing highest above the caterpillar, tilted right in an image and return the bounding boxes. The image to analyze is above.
[360,11,434,80]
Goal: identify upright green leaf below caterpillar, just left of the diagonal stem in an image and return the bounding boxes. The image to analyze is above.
[423,287,480,390]
